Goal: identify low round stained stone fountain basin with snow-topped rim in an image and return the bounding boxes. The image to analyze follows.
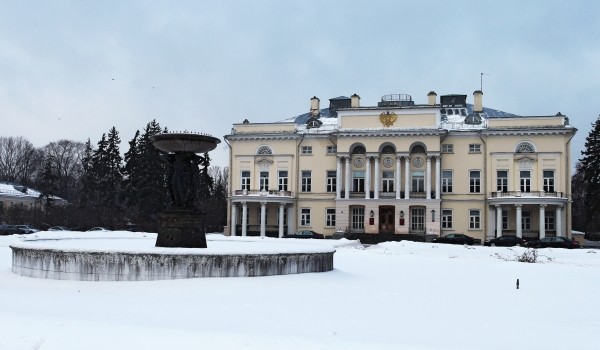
[10,235,335,281]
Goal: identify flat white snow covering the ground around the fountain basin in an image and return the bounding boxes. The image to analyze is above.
[0,234,600,350]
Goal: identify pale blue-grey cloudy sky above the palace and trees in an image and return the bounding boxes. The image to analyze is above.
[0,0,600,166]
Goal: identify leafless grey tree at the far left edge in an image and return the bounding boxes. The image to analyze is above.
[0,136,43,184]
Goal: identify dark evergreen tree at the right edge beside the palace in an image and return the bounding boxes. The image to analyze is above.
[580,117,600,233]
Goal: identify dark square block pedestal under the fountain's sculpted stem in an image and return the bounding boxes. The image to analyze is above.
[156,209,207,248]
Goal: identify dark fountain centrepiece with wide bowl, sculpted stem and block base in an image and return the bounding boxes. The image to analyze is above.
[152,133,221,248]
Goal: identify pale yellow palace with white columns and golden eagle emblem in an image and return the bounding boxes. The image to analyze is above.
[225,91,577,241]
